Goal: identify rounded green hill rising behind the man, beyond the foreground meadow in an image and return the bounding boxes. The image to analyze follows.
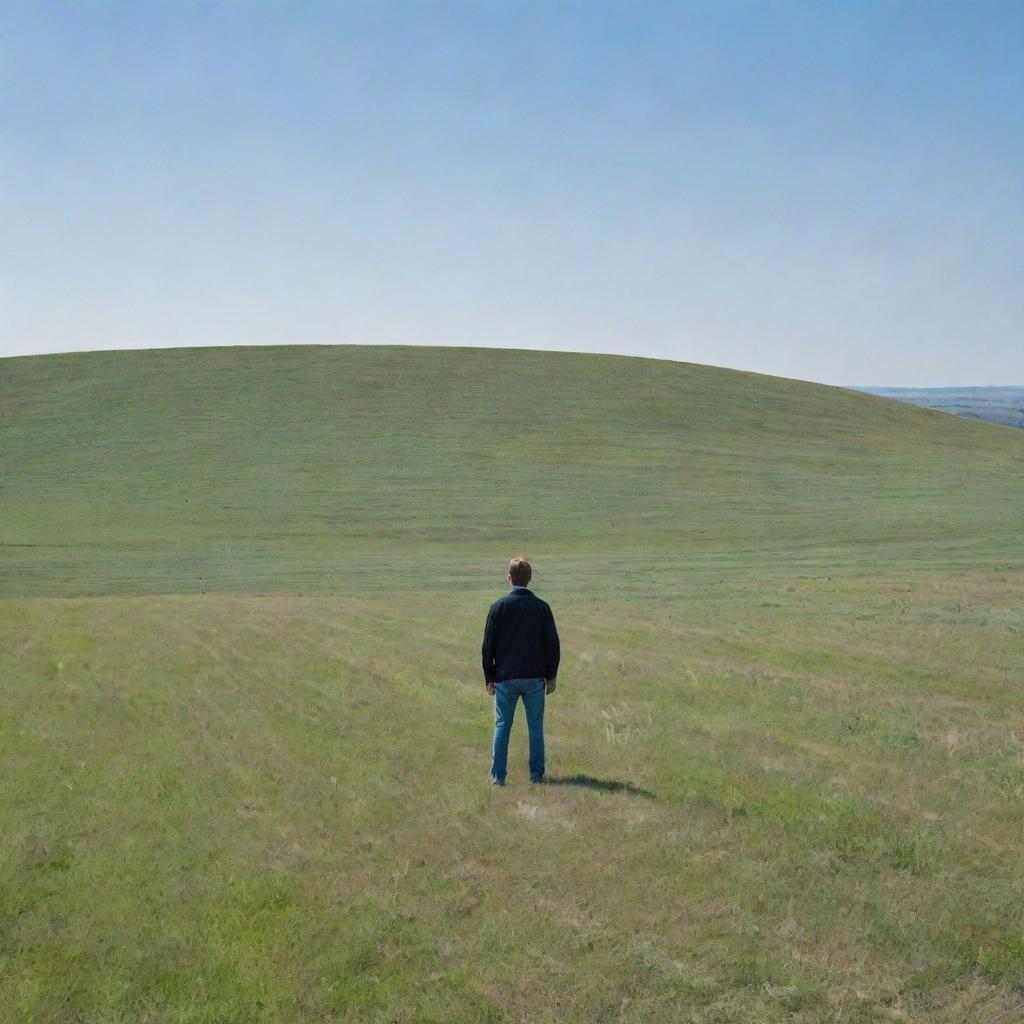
[0,347,1024,594]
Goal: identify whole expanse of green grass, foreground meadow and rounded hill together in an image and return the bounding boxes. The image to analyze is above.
[0,347,1024,1024]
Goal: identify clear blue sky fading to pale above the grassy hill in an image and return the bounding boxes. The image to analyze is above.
[0,0,1024,386]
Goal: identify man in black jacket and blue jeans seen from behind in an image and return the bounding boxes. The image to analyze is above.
[481,558,560,785]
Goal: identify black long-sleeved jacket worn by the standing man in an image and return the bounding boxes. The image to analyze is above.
[481,590,560,683]
